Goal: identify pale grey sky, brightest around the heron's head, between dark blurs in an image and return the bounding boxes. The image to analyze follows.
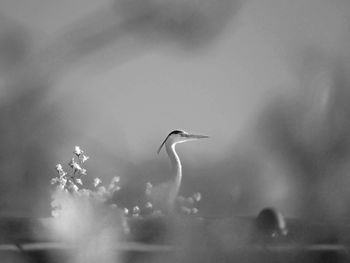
[0,0,349,161]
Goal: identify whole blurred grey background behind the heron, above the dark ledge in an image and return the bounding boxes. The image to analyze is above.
[0,0,350,225]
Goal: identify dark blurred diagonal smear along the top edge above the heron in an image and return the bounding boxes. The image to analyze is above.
[44,0,245,74]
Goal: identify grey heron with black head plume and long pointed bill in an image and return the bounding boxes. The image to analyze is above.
[152,130,209,211]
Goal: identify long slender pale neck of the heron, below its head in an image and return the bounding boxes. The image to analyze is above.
[166,144,182,208]
